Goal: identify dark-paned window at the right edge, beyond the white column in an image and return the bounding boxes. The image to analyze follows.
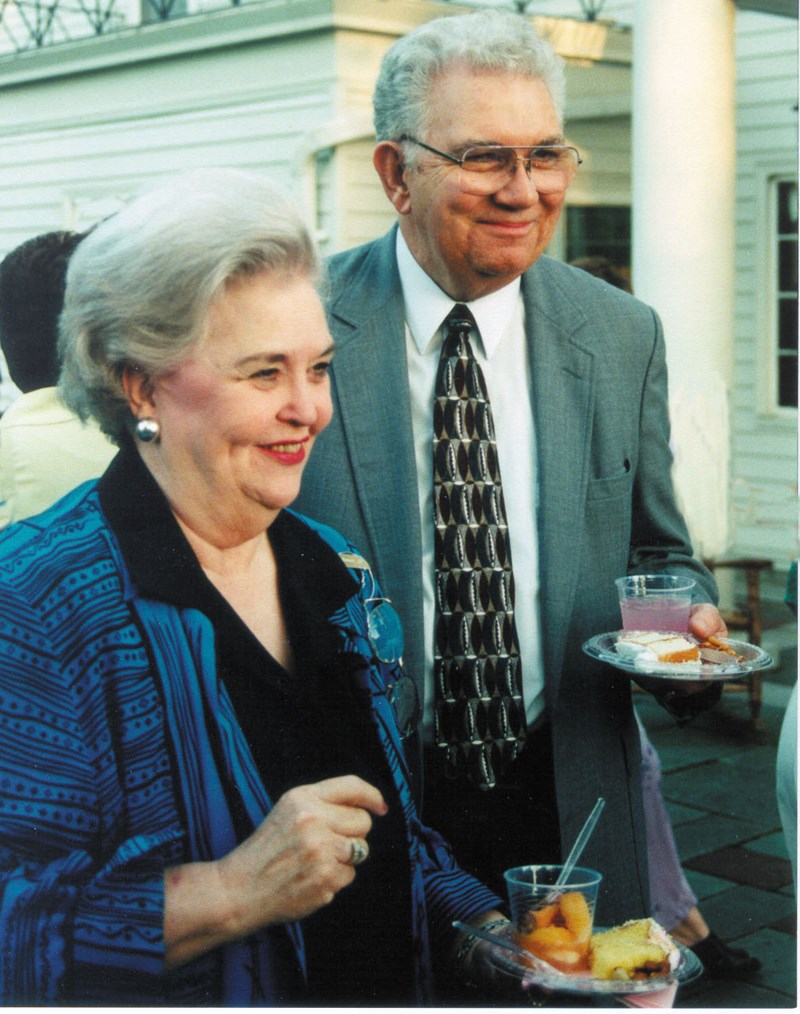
[774,179,798,409]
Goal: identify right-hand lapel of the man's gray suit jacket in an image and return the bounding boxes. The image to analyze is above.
[522,260,594,690]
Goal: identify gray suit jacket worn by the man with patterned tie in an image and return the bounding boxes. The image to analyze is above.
[295,229,715,925]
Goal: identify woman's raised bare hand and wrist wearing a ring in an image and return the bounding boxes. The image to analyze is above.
[164,775,387,967]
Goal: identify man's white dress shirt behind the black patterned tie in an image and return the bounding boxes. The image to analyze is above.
[397,230,544,742]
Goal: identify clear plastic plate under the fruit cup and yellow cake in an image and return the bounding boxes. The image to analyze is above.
[489,927,703,996]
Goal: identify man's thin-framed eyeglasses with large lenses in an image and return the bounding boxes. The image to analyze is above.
[401,135,583,197]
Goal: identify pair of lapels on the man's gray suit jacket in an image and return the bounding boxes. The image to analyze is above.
[322,243,594,697]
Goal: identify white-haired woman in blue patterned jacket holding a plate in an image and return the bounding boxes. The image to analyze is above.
[0,170,499,1006]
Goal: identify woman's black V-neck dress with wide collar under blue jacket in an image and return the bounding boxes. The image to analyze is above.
[99,447,416,1006]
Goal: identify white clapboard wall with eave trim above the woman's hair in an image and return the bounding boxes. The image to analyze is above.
[0,11,337,254]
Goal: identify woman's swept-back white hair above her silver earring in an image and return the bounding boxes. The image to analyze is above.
[59,168,320,443]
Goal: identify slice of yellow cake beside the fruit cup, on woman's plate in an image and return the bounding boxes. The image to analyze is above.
[589,919,680,981]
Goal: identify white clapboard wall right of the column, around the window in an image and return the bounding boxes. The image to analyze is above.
[731,11,797,568]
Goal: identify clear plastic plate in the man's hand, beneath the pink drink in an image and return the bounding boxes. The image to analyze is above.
[583,631,773,681]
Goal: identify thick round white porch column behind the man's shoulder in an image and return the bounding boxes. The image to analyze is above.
[633,0,735,556]
